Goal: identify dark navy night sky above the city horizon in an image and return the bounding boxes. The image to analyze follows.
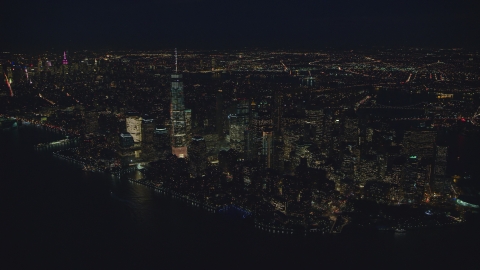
[0,0,480,52]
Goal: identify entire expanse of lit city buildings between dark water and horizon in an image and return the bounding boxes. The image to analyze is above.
[0,48,480,233]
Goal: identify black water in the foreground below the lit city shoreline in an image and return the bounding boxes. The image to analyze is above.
[0,127,480,269]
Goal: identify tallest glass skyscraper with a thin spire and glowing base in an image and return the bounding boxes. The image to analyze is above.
[170,49,189,158]
